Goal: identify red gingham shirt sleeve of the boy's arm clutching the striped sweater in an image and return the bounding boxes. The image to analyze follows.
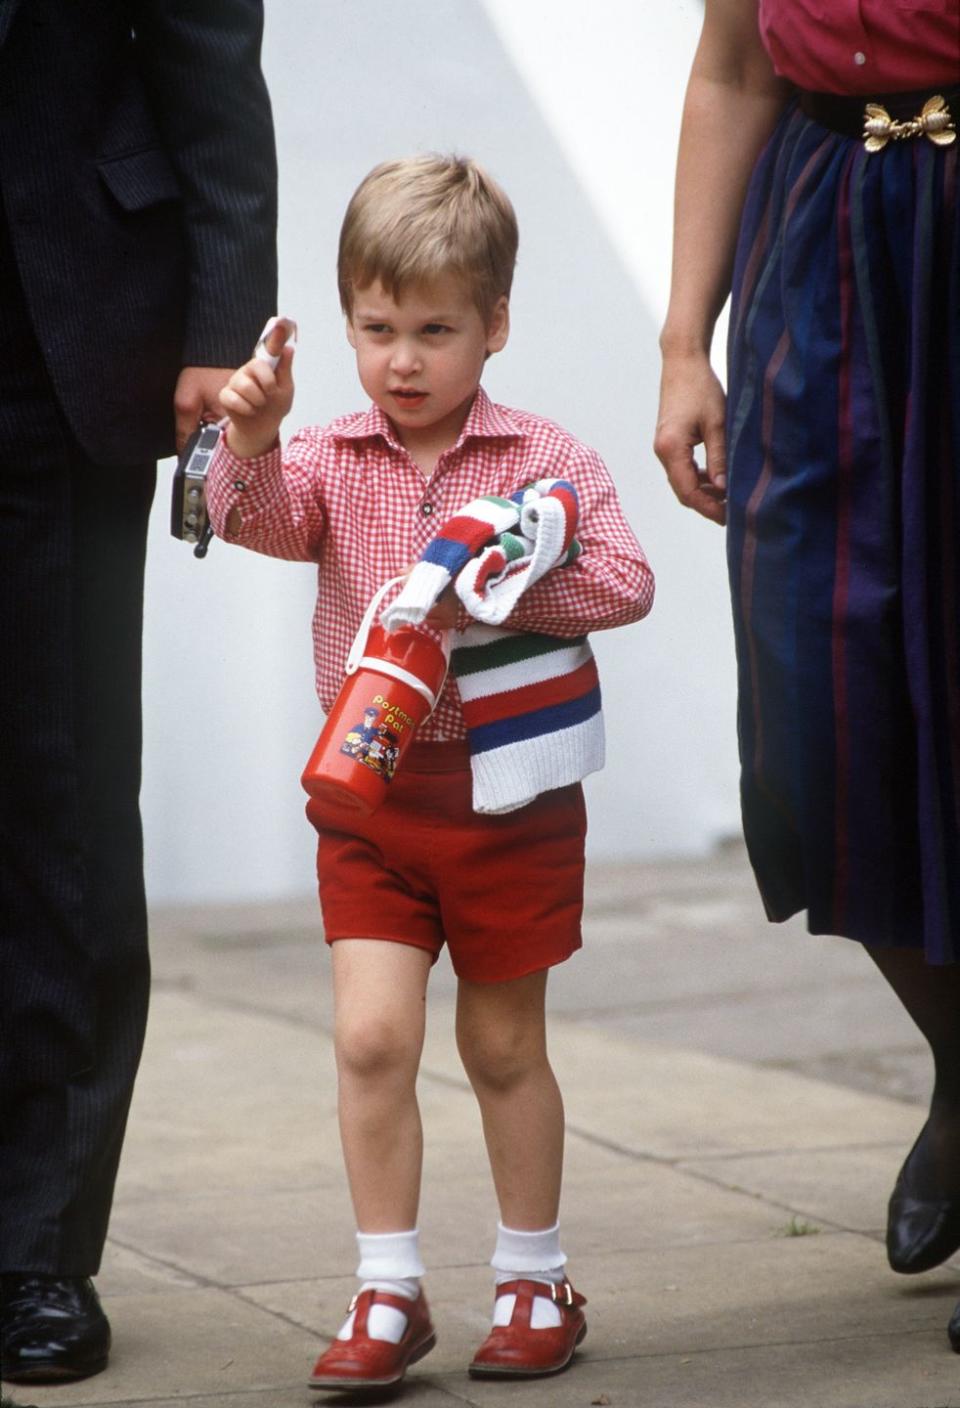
[504,445,653,636]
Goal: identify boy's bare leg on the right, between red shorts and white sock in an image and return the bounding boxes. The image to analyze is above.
[456,972,563,1231]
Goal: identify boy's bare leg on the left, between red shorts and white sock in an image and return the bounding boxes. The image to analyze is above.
[332,939,431,1233]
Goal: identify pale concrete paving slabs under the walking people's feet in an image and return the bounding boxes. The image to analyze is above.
[7,848,960,1408]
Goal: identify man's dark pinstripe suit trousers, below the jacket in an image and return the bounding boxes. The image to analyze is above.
[0,195,155,1276]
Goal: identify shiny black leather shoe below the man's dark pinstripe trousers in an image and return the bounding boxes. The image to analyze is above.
[0,1271,110,1384]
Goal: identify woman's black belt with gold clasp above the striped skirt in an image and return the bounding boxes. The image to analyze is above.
[800,86,960,152]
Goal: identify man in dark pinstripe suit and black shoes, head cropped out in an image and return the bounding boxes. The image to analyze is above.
[0,0,276,1381]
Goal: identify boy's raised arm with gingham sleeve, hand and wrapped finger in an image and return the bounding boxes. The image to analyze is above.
[207,321,325,562]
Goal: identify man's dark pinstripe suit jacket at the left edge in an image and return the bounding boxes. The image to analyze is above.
[0,0,276,465]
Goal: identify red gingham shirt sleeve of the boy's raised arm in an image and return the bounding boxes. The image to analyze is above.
[207,429,327,562]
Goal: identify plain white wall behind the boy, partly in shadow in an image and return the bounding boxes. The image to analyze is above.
[144,0,738,900]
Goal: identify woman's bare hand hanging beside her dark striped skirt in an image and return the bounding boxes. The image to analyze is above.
[653,352,726,524]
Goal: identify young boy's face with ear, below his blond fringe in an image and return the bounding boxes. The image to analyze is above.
[346,276,510,452]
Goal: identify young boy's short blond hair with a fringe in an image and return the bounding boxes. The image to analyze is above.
[336,155,518,322]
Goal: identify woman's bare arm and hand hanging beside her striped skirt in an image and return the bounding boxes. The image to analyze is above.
[653,0,790,522]
